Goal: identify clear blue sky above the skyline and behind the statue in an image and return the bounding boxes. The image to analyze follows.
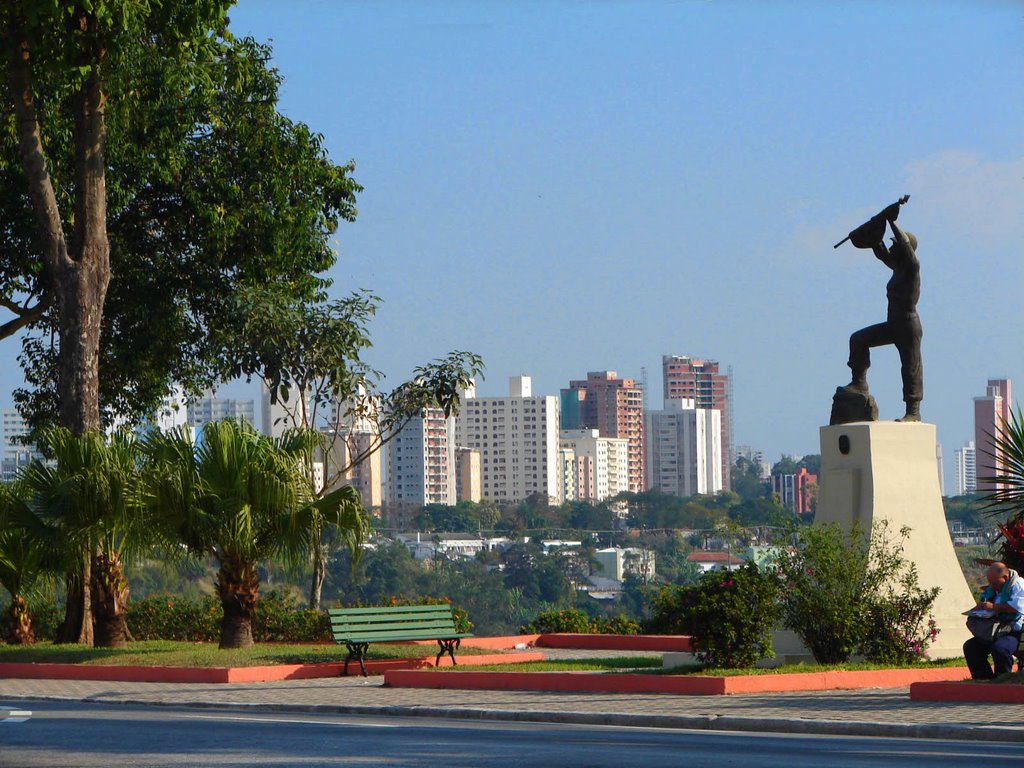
[0,0,1024,493]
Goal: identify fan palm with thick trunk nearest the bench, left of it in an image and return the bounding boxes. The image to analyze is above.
[145,420,369,648]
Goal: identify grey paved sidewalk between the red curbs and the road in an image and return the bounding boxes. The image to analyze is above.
[0,677,1024,741]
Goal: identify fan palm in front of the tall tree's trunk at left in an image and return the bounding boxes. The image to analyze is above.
[16,428,153,647]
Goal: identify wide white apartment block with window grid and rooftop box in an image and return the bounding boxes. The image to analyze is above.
[456,376,565,504]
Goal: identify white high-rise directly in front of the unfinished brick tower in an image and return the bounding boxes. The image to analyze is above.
[644,398,723,498]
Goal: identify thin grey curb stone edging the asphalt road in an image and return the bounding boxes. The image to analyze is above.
[5,694,1024,742]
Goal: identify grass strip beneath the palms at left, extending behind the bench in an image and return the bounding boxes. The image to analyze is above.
[0,640,495,667]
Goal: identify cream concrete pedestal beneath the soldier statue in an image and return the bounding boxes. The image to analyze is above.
[815,421,976,658]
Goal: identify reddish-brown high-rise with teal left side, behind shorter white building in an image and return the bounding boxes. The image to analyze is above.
[560,371,647,493]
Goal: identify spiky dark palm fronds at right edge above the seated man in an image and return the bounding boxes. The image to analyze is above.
[979,407,1024,572]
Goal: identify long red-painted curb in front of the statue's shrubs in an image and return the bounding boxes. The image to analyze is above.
[384,667,969,696]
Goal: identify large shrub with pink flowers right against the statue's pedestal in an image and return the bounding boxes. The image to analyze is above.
[775,521,938,664]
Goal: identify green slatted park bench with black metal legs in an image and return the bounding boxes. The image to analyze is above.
[328,605,472,677]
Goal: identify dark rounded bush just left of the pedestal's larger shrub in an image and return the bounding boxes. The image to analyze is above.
[675,563,781,669]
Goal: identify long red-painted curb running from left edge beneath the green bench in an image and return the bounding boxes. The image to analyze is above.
[0,652,544,683]
